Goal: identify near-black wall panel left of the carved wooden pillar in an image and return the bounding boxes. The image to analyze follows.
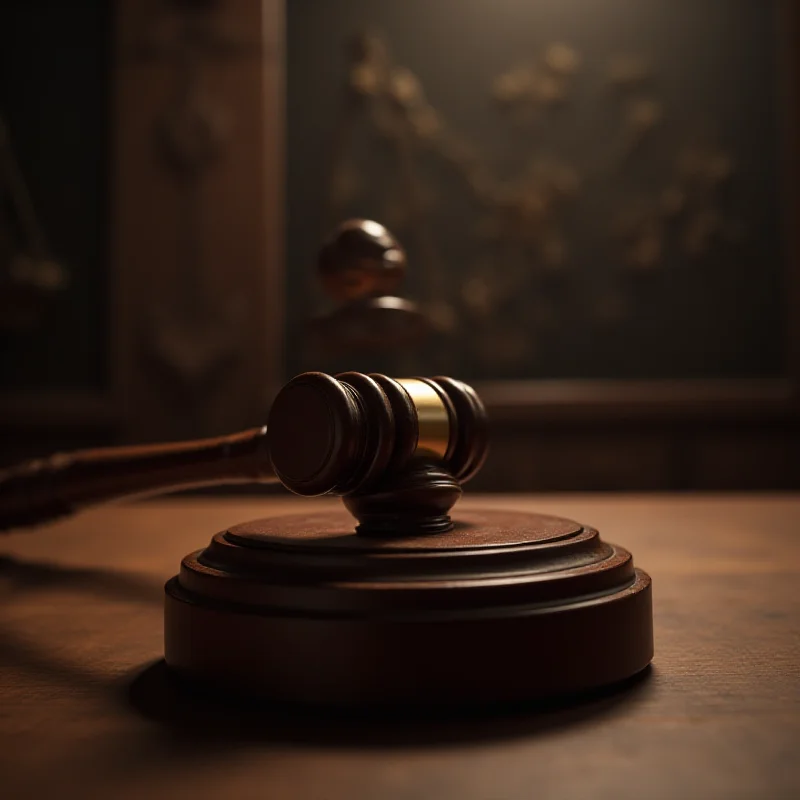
[0,0,113,389]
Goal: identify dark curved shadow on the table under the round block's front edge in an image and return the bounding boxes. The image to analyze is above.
[126,661,652,748]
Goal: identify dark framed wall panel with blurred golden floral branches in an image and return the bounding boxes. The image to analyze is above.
[287,0,790,379]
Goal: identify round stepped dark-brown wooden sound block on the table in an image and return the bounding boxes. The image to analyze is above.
[165,510,653,707]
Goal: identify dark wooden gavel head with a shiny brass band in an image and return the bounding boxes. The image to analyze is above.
[267,372,488,495]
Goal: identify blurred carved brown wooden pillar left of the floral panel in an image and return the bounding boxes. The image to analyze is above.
[114,0,283,439]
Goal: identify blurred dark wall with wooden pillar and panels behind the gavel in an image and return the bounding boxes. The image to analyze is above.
[0,0,800,491]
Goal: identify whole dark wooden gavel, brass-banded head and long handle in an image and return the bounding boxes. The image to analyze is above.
[0,372,487,530]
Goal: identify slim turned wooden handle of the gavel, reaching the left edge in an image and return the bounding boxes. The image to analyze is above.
[0,426,278,531]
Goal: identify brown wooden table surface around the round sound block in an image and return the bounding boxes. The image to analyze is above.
[0,495,800,800]
